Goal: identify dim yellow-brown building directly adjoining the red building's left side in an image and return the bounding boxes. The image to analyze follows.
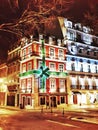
[6,42,20,106]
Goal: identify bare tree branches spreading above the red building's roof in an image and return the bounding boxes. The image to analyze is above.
[0,0,74,38]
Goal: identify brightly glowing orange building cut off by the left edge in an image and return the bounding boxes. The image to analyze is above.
[0,63,8,106]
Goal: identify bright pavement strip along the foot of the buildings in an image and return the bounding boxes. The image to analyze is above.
[0,104,98,112]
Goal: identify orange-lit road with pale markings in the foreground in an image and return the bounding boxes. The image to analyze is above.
[0,108,98,130]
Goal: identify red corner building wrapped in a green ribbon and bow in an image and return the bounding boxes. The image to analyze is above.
[20,35,68,108]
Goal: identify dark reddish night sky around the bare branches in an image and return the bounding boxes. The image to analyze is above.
[0,0,98,61]
